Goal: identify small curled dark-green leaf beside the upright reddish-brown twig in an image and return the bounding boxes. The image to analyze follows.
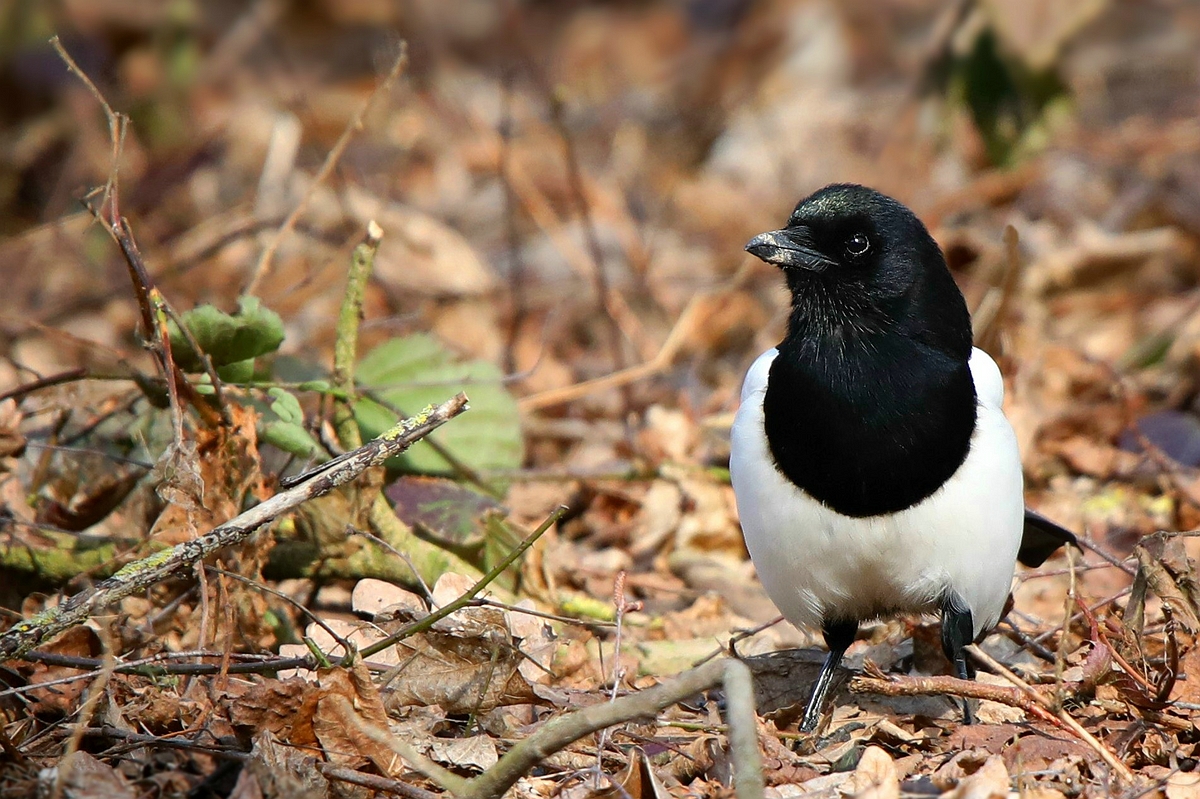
[168,296,283,377]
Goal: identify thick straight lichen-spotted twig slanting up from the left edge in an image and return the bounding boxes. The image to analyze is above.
[0,394,467,662]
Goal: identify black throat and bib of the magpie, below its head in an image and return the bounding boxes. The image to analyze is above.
[763,283,976,517]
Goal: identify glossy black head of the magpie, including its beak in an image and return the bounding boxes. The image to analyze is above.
[745,184,971,359]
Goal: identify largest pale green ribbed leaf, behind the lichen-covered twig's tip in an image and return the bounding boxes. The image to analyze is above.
[354,335,524,471]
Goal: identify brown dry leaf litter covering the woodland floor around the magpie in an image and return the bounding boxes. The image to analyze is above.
[0,0,1200,799]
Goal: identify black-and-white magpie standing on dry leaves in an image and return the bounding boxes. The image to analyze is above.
[730,184,1078,732]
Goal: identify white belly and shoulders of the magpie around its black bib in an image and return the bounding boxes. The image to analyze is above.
[730,349,1025,636]
